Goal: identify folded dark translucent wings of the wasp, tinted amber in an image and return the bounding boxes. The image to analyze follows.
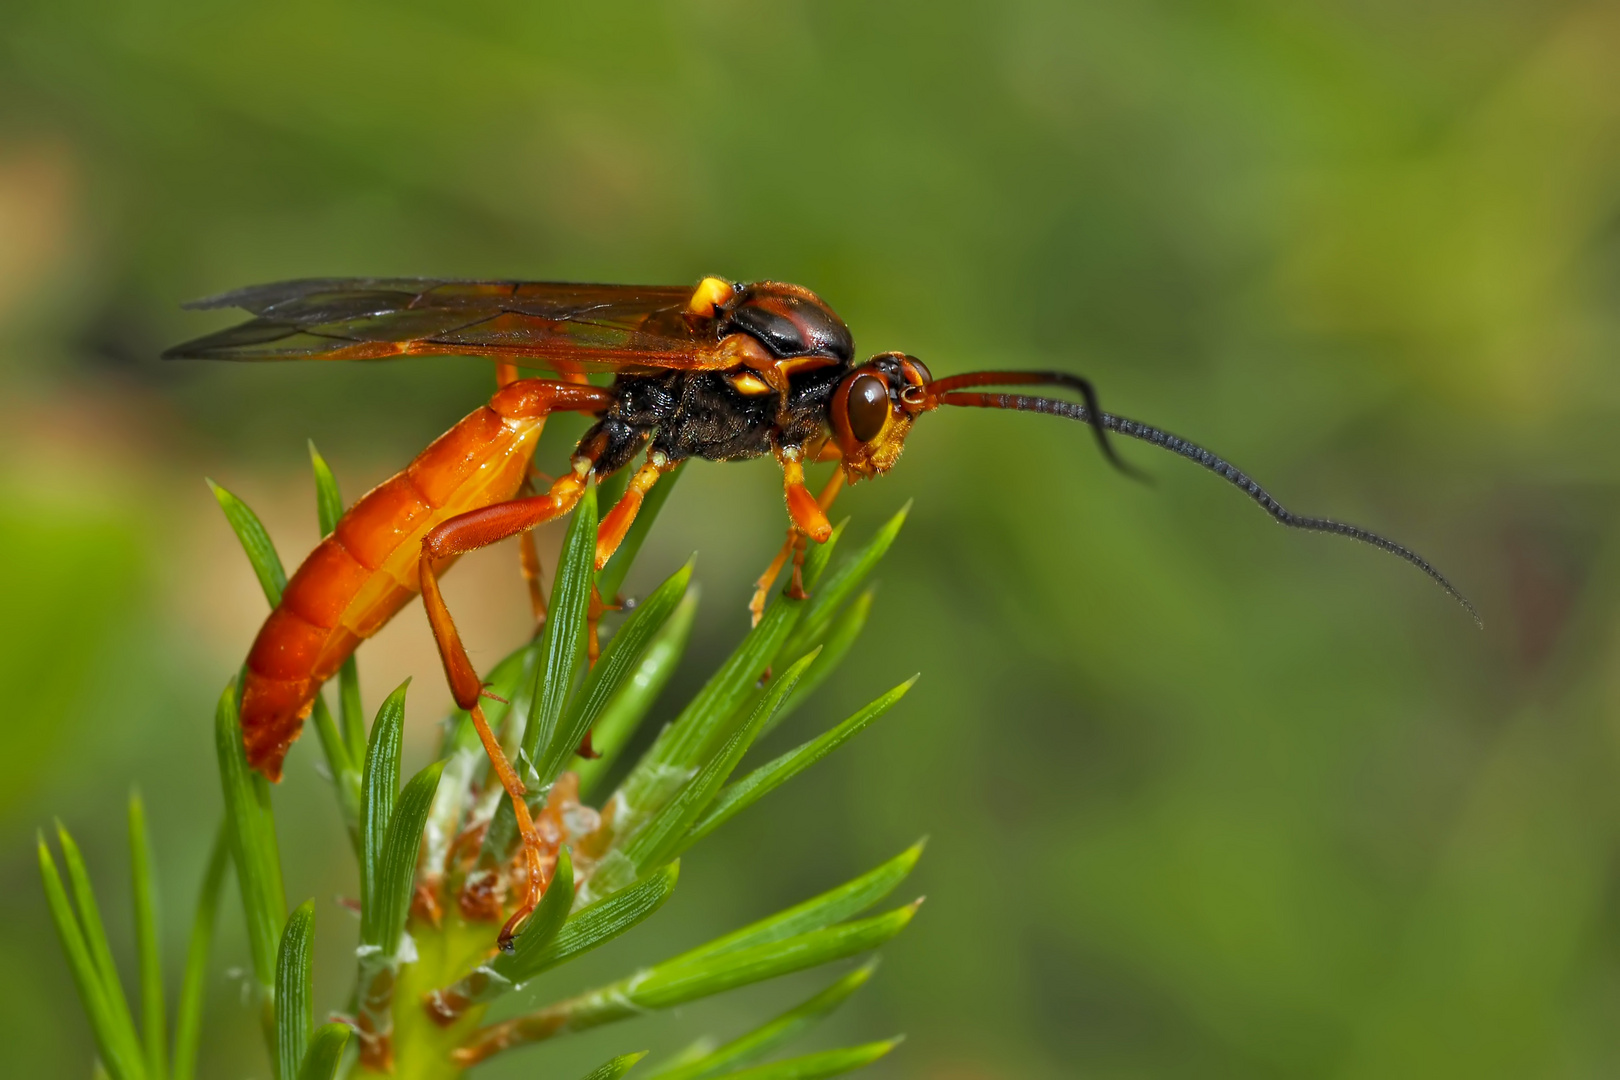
[164,277,714,372]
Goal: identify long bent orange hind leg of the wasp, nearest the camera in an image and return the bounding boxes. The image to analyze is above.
[421,457,591,949]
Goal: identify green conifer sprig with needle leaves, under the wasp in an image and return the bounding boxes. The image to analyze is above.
[39,444,922,1080]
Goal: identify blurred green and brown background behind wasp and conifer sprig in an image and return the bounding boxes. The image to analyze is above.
[0,0,1620,1080]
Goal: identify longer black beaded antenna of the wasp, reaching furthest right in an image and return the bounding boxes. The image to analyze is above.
[938,392,1486,630]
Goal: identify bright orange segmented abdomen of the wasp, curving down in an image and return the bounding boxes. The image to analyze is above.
[241,405,546,780]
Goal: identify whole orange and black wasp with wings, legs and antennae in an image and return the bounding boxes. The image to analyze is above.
[165,277,1479,944]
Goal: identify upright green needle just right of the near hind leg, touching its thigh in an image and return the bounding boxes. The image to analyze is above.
[523,487,596,764]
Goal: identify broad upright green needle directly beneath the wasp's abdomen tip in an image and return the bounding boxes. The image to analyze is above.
[214,683,287,1001]
